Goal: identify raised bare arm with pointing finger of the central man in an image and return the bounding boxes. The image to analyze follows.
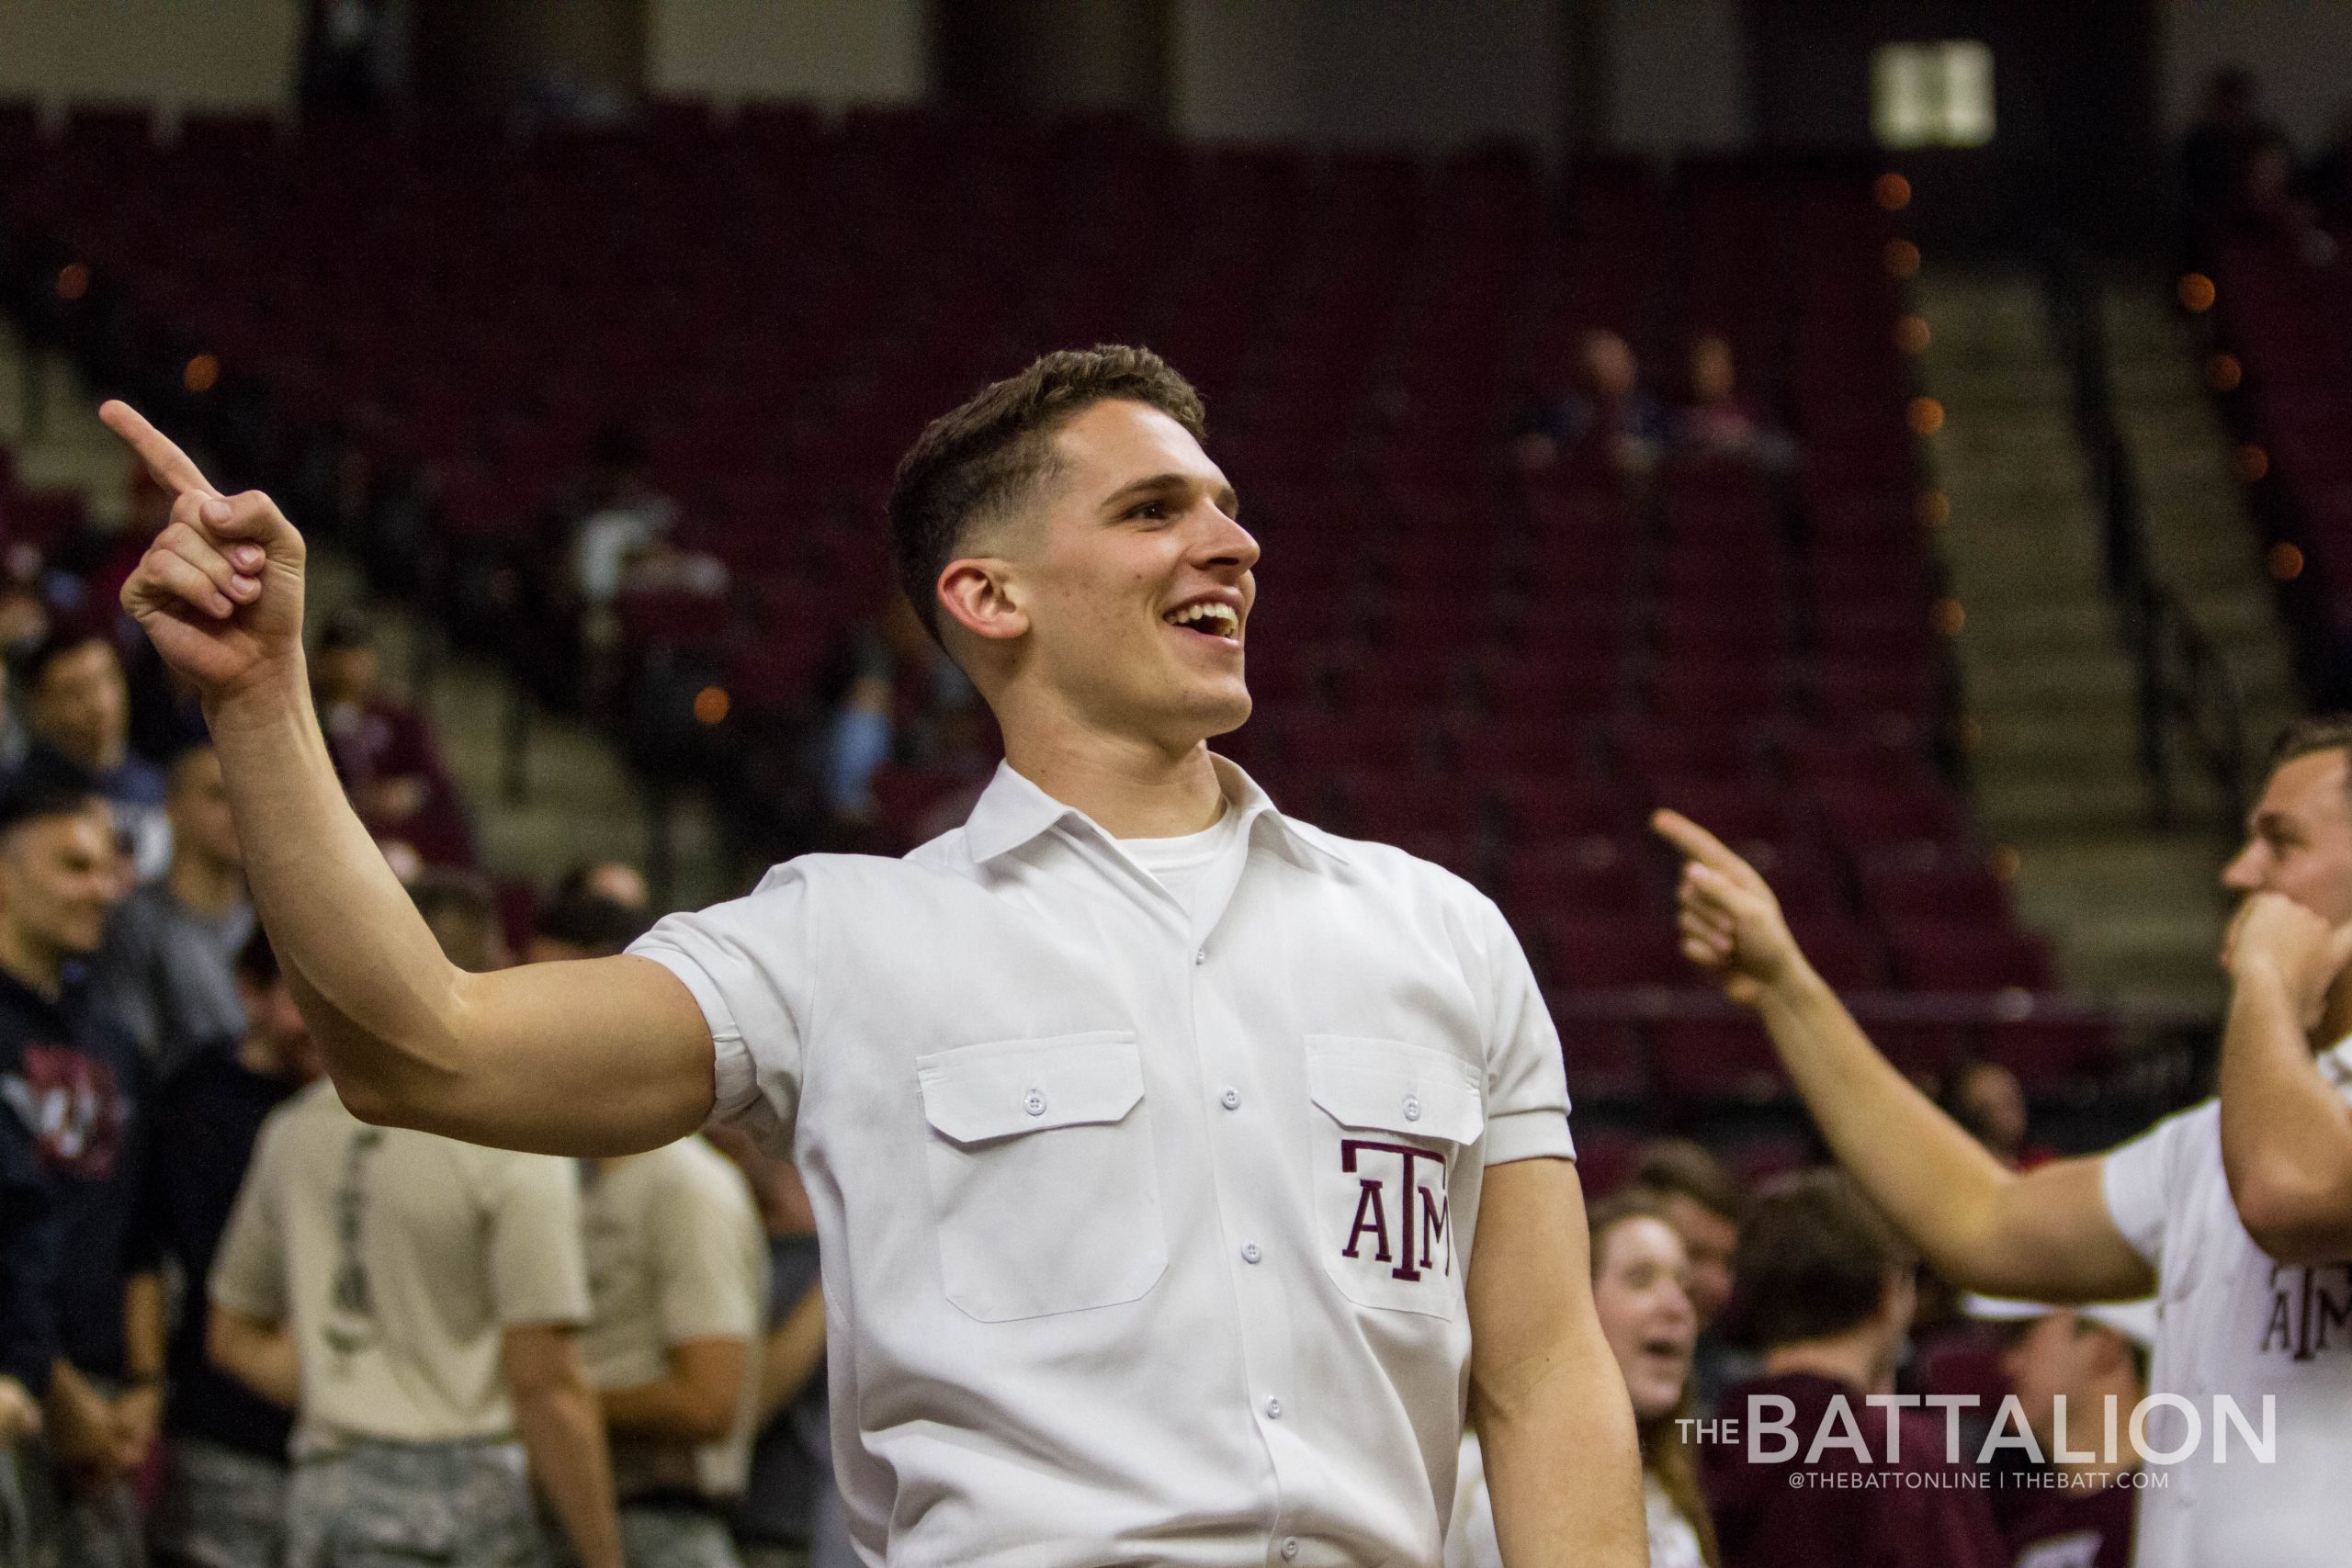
[99,402,713,1155]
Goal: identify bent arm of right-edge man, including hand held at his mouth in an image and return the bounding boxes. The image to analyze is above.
[2221,894,2352,1265]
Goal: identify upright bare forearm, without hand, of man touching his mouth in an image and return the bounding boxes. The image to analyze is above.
[2221,964,2352,1262]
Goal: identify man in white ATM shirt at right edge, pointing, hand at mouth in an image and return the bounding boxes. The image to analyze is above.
[1658,717,2352,1568]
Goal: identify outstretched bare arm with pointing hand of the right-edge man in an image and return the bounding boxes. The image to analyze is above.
[1651,811,2154,1303]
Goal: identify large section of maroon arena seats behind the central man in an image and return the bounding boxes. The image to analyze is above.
[0,106,2108,1123]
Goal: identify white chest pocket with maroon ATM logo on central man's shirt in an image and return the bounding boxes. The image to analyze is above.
[1307,1034,1487,1316]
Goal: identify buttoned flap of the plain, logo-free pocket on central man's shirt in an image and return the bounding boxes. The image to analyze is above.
[915,1030,1143,1143]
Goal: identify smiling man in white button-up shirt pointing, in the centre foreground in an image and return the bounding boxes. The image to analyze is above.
[106,348,1646,1568]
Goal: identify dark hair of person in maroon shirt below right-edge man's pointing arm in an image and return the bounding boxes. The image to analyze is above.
[1731,1168,1915,1349]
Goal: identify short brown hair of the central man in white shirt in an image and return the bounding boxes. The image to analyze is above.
[889,344,1209,637]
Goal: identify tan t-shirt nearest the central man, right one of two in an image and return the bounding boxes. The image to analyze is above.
[581,1138,767,1500]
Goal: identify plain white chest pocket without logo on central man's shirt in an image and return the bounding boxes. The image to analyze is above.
[915,1030,1169,1324]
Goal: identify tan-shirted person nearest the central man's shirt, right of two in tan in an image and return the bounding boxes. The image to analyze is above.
[581,1138,767,1568]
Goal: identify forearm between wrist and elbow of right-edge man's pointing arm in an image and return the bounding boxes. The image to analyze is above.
[1757,966,2011,1286]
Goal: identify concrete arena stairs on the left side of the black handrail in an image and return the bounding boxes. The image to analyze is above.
[1917,270,2234,1006]
